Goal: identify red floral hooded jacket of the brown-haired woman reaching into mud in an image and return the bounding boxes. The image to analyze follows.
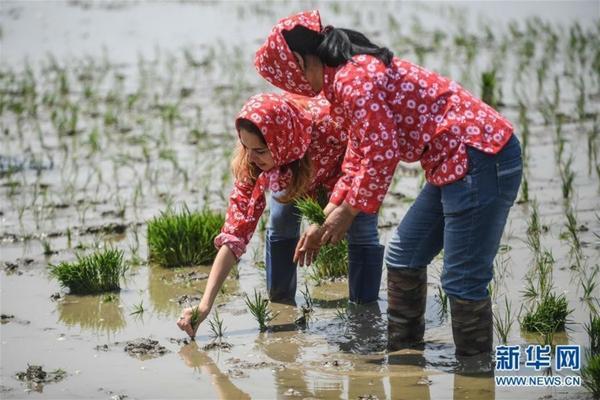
[215,93,347,259]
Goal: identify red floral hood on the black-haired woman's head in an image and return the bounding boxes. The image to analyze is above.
[254,10,322,97]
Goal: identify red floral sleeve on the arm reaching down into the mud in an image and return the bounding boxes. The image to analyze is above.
[214,180,266,259]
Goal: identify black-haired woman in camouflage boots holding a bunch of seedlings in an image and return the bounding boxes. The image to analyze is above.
[255,11,522,356]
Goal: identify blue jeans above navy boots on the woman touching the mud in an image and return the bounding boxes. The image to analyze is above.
[267,193,379,246]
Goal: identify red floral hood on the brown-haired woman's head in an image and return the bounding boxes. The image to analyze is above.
[236,93,312,167]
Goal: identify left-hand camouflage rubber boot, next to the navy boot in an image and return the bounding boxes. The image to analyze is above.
[387,267,427,351]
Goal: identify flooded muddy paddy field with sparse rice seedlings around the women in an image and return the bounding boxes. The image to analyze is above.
[0,1,600,400]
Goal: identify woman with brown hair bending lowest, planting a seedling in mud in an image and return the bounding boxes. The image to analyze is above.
[177,93,383,336]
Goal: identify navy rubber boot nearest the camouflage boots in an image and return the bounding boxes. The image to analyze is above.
[348,245,384,304]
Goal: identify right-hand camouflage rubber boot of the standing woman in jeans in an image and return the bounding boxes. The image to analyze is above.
[450,297,494,358]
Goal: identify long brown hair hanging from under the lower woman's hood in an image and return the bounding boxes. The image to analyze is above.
[231,119,313,204]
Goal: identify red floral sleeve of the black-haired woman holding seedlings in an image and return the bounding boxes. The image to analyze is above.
[330,72,400,214]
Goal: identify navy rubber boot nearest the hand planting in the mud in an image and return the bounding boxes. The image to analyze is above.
[265,235,298,304]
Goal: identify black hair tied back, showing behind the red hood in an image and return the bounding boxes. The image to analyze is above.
[282,25,394,67]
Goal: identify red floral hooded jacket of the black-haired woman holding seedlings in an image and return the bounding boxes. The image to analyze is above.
[255,10,513,213]
